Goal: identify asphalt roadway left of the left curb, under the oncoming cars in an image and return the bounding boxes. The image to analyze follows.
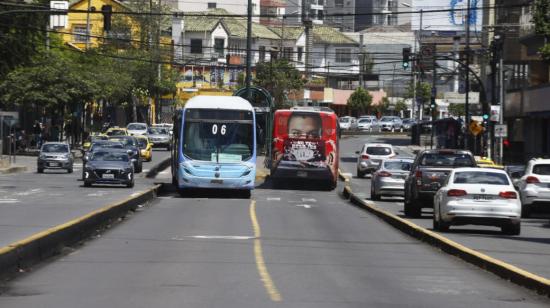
[0,149,170,247]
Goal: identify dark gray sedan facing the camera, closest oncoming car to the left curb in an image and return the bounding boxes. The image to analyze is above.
[83,149,134,187]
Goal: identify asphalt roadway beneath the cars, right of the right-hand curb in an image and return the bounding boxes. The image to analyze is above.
[340,136,550,278]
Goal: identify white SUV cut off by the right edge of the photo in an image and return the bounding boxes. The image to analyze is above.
[516,158,550,217]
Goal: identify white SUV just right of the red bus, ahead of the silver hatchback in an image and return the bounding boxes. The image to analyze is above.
[355,143,397,178]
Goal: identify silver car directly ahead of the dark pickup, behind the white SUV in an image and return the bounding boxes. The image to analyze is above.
[370,158,413,201]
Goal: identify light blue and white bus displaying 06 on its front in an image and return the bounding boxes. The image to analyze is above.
[172,95,256,197]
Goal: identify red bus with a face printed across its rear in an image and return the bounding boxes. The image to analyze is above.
[271,107,340,190]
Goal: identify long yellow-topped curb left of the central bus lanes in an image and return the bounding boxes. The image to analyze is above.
[0,185,161,277]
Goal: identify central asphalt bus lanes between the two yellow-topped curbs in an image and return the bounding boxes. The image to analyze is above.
[0,160,550,308]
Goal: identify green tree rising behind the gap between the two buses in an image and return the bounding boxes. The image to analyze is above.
[254,59,304,108]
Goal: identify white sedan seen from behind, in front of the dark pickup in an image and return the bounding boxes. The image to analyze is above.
[433,168,521,235]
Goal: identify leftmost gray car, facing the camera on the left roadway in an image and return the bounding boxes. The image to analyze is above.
[36,142,74,173]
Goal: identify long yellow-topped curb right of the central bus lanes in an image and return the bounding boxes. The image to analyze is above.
[339,172,550,297]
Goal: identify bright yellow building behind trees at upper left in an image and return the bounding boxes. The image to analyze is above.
[63,0,131,49]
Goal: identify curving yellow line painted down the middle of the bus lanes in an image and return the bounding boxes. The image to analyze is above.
[250,200,282,302]
